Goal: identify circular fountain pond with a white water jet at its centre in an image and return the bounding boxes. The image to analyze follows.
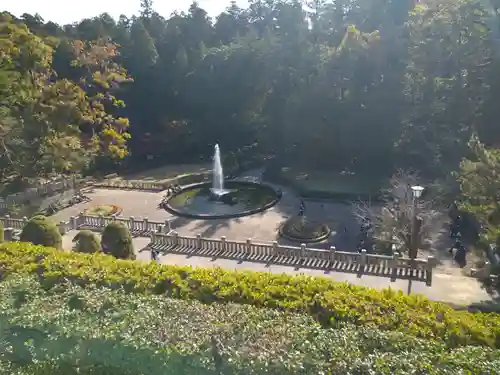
[165,181,281,219]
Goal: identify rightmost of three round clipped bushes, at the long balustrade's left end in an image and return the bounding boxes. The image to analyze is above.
[101,223,135,259]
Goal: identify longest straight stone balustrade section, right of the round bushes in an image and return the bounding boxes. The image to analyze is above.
[150,226,437,285]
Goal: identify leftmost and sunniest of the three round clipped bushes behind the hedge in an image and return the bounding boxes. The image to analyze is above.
[19,215,62,249]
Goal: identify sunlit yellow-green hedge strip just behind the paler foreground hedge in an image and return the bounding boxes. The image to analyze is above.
[0,243,500,347]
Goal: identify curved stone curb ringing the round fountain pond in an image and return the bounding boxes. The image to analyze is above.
[164,180,283,220]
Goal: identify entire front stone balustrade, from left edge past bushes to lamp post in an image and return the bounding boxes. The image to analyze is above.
[0,214,446,285]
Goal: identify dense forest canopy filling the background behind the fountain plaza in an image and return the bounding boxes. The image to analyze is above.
[0,0,500,182]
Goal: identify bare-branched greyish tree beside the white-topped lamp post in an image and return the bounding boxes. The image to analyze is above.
[353,170,443,257]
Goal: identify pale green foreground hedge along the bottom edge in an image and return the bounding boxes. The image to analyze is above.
[0,275,500,375]
